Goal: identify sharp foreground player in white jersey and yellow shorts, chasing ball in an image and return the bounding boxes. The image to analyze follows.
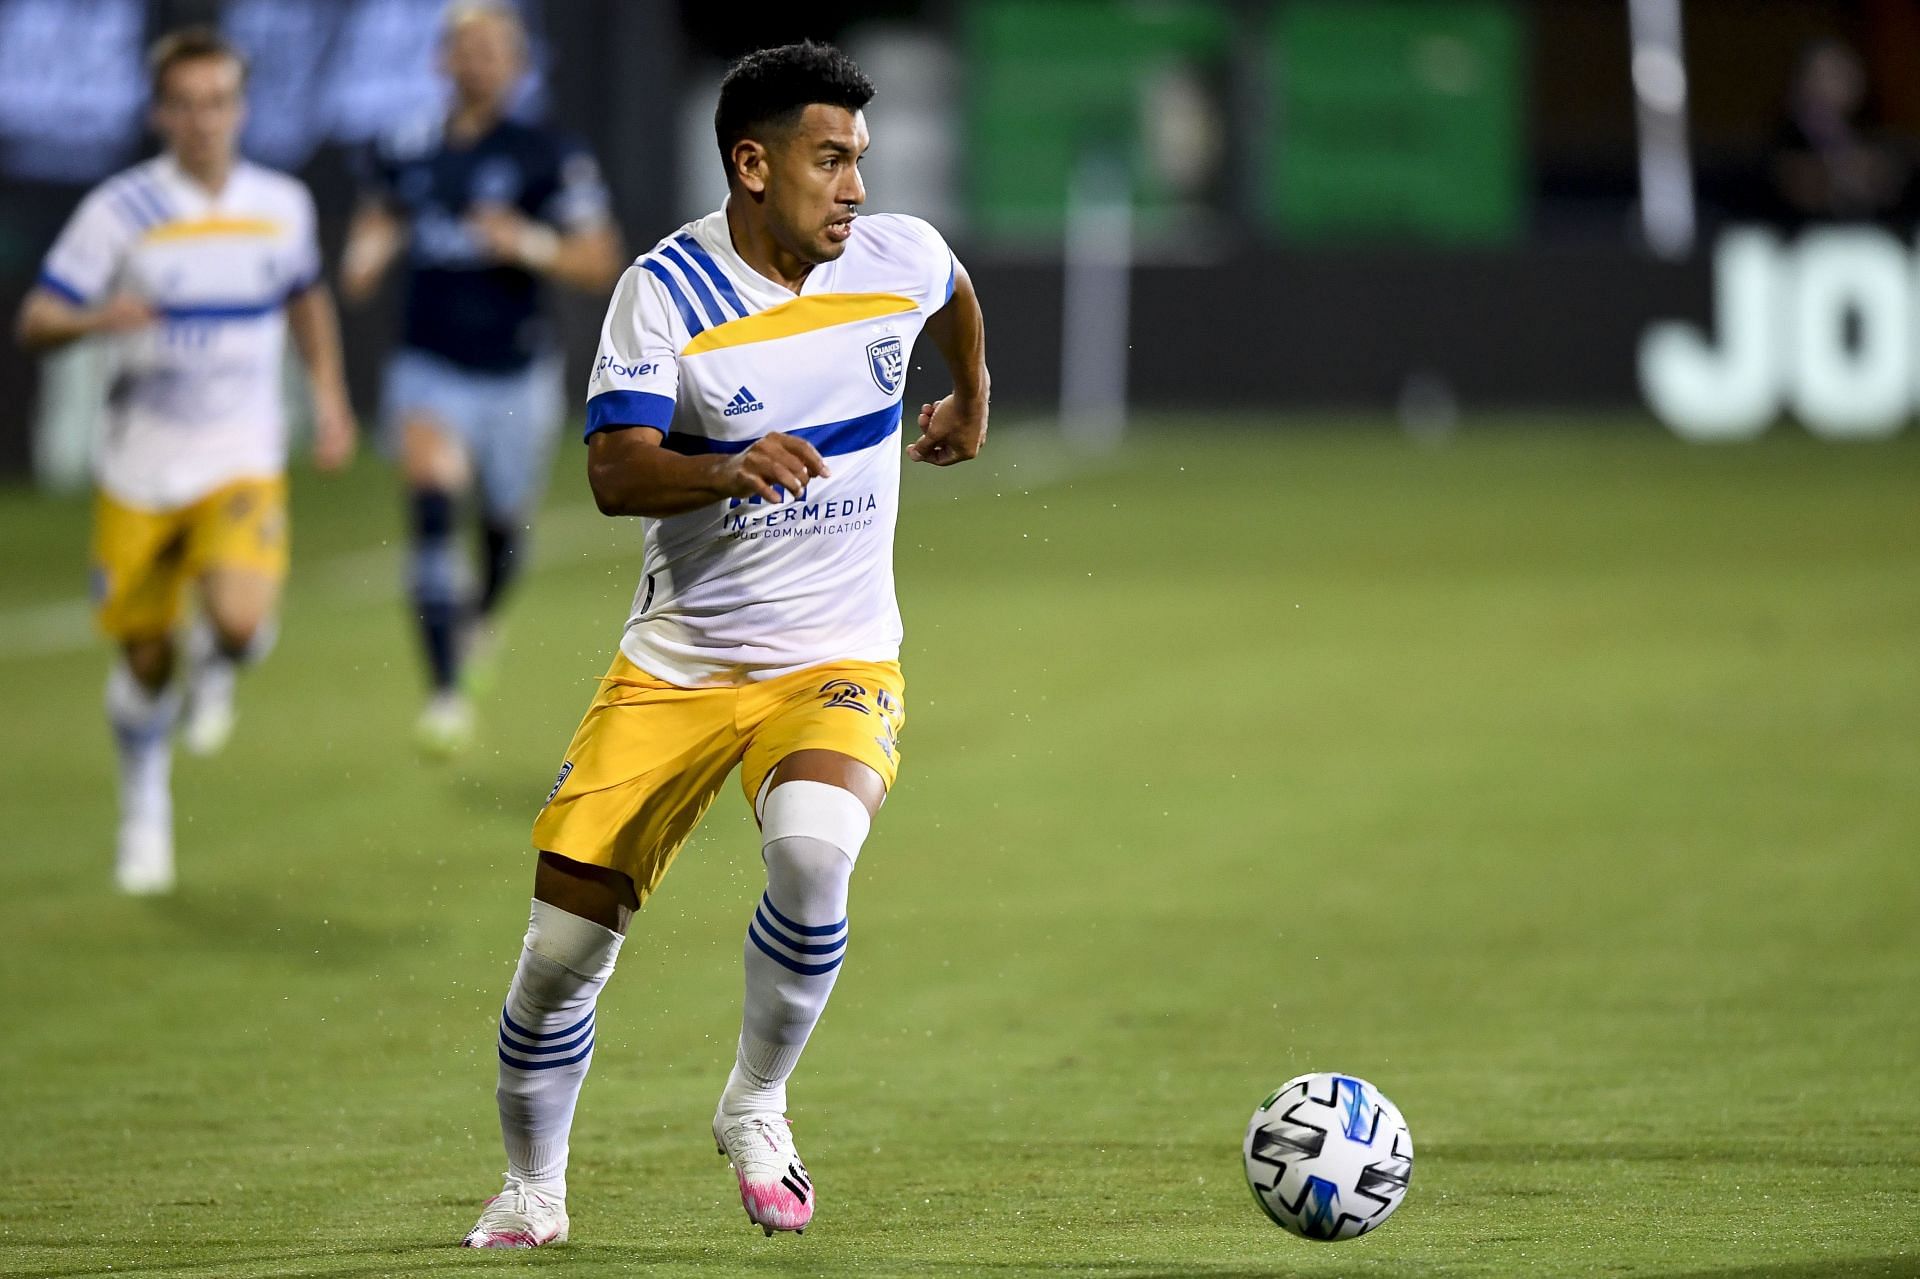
[465,44,987,1248]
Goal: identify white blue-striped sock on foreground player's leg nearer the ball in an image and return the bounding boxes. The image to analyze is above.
[720,782,872,1116]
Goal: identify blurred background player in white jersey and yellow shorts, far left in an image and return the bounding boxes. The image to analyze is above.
[19,29,353,893]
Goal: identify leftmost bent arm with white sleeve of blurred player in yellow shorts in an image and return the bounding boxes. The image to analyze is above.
[15,188,156,351]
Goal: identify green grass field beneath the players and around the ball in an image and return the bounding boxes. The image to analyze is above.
[0,412,1920,1279]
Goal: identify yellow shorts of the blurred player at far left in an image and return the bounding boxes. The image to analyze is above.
[92,476,286,641]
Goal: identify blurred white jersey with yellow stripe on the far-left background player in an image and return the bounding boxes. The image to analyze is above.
[40,156,321,511]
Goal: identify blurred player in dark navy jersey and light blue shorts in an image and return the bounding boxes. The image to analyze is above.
[342,4,622,753]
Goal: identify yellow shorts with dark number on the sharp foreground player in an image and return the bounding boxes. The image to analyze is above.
[534,653,906,901]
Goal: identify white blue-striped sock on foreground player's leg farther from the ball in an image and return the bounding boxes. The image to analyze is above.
[495,899,624,1198]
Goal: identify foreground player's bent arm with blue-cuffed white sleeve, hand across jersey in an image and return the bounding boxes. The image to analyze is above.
[588,267,828,519]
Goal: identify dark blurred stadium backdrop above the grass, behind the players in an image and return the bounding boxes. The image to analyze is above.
[11,0,1920,453]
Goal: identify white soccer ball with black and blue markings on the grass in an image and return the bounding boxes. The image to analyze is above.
[1240,1074,1413,1241]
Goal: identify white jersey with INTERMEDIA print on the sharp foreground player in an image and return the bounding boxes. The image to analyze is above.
[588,211,954,686]
